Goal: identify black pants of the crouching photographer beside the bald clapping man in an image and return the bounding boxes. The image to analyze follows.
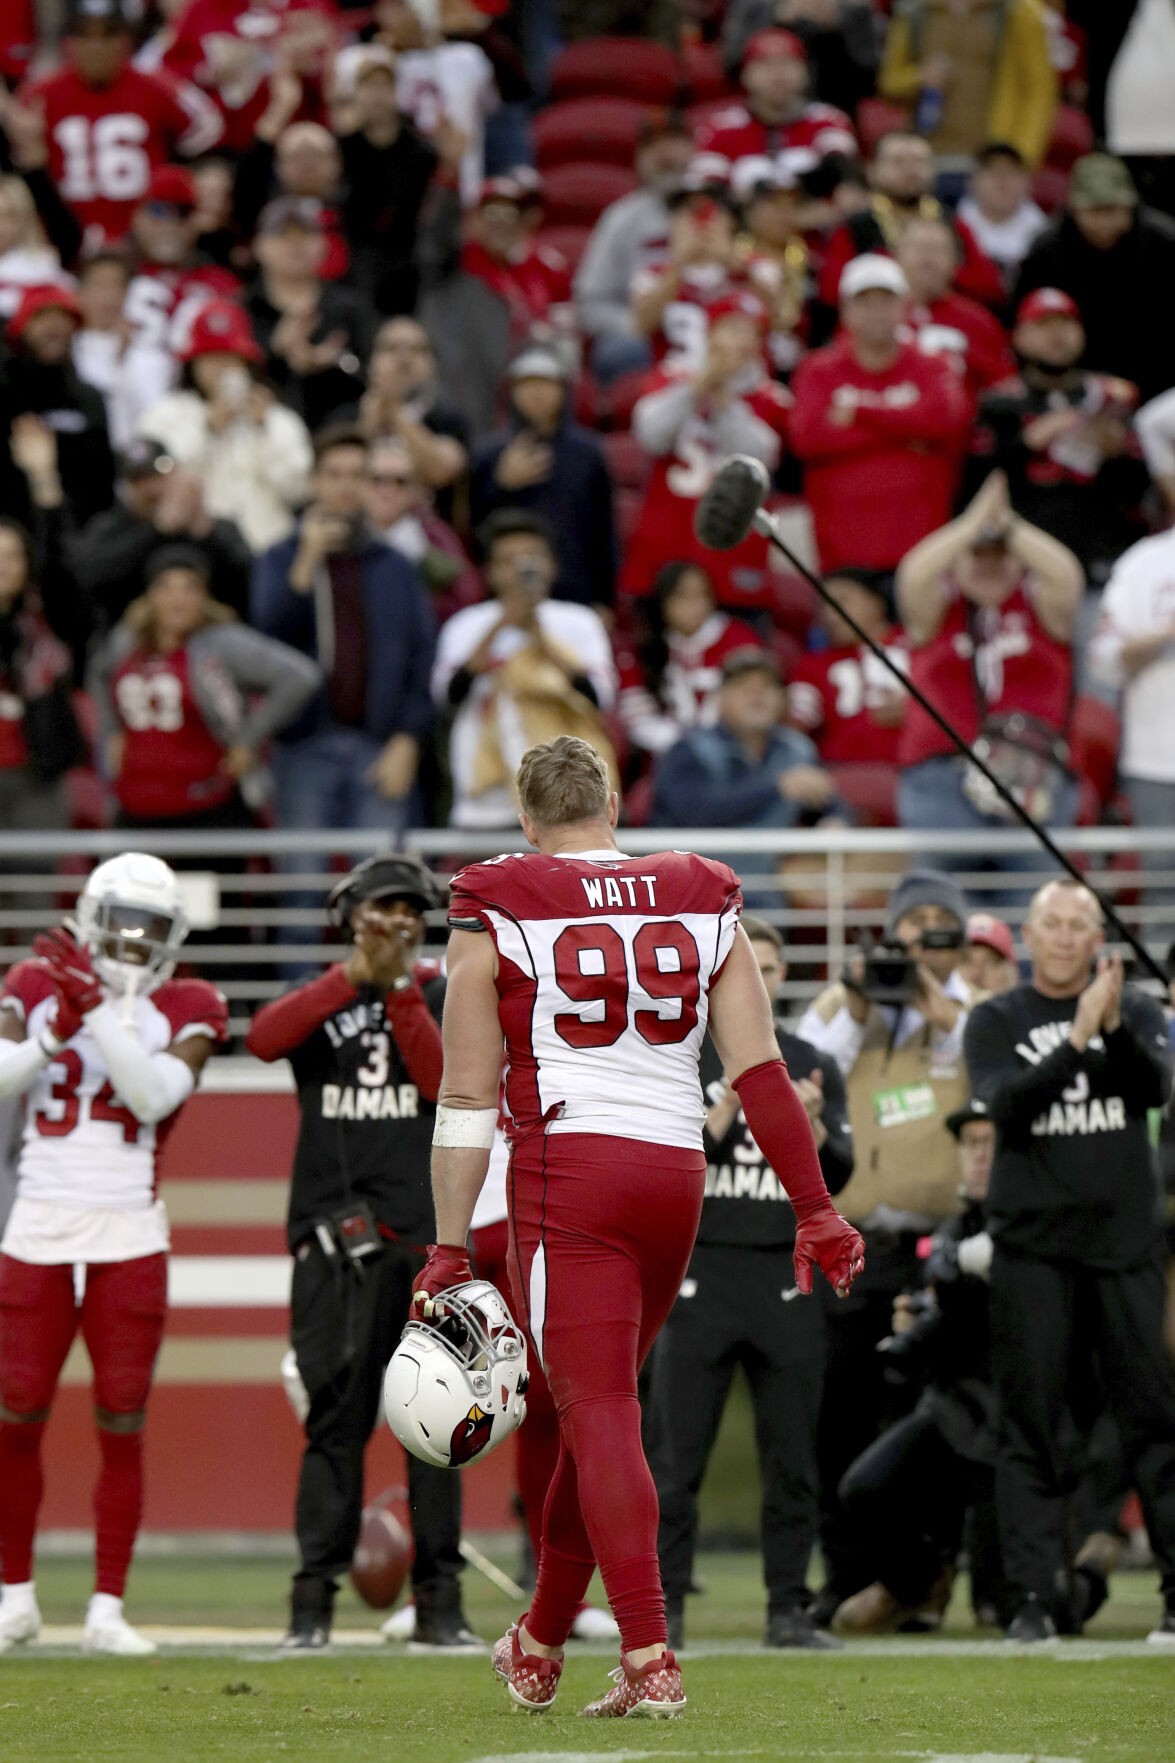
[840,1410,993,1608]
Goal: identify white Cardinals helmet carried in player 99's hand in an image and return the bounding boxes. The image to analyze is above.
[383,1280,529,1469]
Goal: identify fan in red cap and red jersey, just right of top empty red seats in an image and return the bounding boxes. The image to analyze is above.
[699,30,857,185]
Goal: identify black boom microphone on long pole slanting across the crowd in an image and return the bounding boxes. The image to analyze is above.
[693,453,1166,993]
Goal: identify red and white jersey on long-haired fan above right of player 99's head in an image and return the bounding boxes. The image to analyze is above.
[616,612,762,753]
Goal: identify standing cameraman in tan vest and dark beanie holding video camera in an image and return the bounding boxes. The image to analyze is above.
[797,869,972,1622]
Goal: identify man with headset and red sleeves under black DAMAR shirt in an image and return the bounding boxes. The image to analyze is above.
[247,855,478,1648]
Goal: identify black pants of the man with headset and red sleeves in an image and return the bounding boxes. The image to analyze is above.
[289,1238,460,1601]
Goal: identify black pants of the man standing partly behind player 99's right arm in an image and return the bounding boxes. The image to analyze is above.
[651,1245,824,1611]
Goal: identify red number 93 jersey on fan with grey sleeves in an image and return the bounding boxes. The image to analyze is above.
[111,649,235,820]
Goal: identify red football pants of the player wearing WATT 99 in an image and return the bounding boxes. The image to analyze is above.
[508,1134,706,1414]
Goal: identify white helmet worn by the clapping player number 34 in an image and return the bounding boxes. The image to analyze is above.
[78,852,187,993]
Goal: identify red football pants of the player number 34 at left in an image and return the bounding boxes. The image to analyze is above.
[0,1255,168,1414]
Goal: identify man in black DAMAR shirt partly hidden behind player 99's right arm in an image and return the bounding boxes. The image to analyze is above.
[649,917,852,1648]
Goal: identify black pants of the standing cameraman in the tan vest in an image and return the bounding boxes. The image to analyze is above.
[817,1231,921,1599]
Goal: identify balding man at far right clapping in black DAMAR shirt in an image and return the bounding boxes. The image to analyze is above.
[963,880,1175,1641]
